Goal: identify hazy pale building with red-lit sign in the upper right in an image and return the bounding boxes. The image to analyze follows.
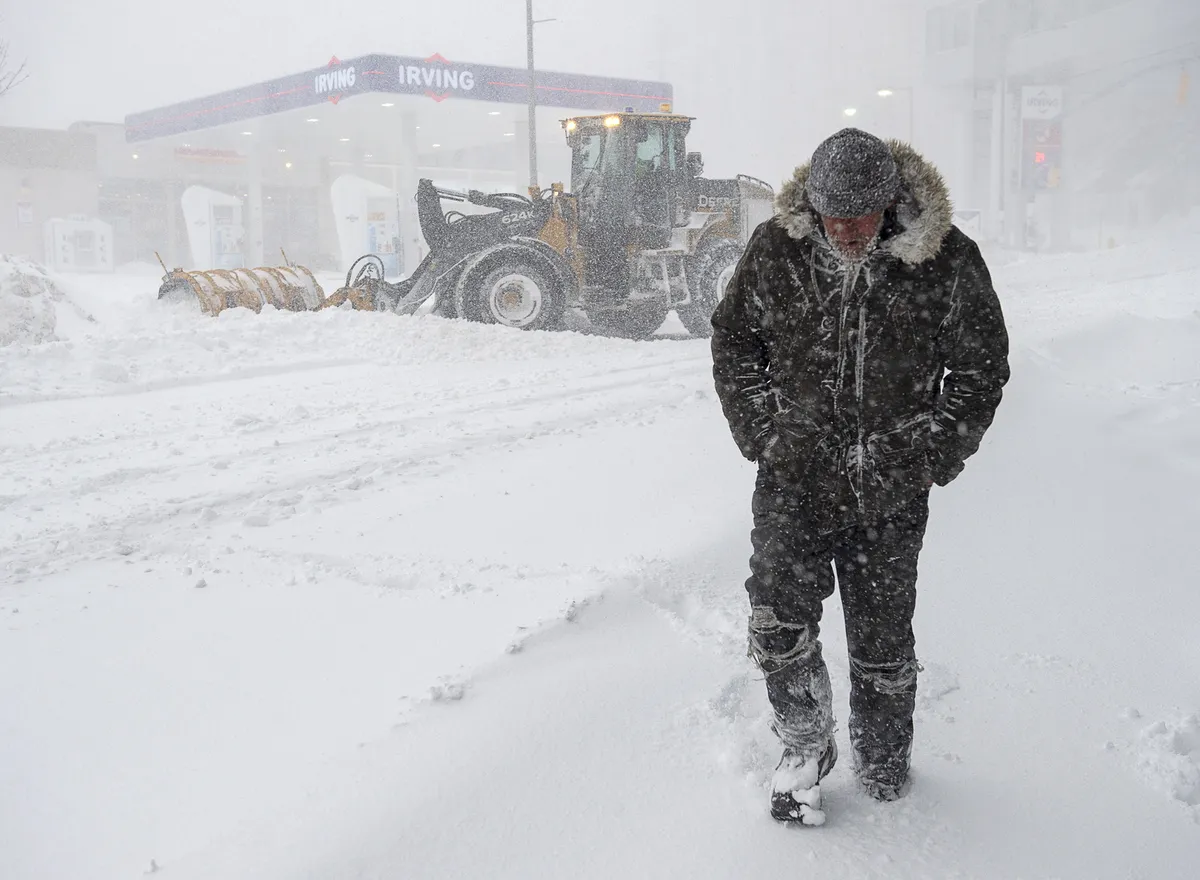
[923,0,1200,250]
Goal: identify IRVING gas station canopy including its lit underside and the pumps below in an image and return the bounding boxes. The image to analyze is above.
[115,54,672,273]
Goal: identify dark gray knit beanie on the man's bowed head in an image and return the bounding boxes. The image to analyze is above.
[804,128,900,217]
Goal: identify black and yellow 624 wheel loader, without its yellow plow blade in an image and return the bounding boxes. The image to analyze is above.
[333,113,774,339]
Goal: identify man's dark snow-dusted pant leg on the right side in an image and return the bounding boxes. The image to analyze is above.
[836,493,929,789]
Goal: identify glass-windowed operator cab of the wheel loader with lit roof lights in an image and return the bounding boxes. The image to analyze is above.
[563,113,692,286]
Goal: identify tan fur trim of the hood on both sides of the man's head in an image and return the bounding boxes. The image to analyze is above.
[775,140,954,265]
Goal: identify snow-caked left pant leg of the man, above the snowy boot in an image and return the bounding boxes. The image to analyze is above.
[746,478,834,758]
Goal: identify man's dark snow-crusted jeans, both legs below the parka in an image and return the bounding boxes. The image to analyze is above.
[746,475,929,786]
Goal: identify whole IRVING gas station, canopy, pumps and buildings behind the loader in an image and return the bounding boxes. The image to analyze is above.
[0,55,673,275]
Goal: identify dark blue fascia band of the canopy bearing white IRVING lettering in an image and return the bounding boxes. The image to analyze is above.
[125,55,672,143]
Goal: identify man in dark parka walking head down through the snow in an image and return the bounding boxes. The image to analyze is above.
[713,128,1008,825]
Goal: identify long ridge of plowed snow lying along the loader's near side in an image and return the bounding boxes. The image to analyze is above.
[0,292,691,401]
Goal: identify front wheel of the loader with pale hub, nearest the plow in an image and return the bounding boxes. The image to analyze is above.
[455,250,566,330]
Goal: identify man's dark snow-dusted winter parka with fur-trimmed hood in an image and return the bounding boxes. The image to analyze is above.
[713,142,1008,531]
